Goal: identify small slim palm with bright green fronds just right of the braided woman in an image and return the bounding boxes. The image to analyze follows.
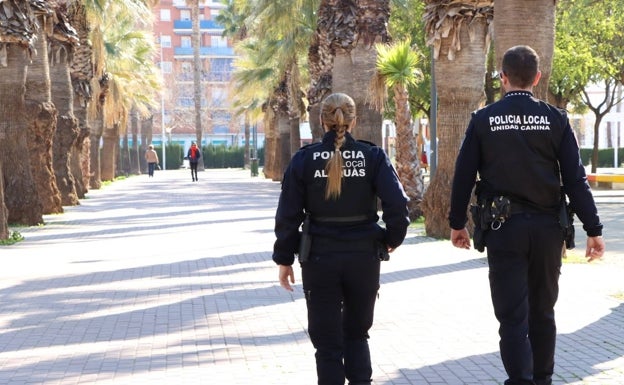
[376,40,425,220]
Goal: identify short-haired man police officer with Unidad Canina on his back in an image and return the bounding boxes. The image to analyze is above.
[449,46,605,385]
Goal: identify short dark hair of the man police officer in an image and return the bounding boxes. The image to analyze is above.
[502,45,539,88]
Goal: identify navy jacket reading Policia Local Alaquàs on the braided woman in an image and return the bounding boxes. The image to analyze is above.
[273,131,409,265]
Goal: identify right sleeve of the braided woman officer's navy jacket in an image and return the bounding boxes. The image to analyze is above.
[374,147,410,248]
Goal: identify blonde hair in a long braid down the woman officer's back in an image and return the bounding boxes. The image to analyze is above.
[321,93,355,199]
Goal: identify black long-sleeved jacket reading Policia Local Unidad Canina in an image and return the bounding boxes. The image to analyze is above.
[449,91,602,236]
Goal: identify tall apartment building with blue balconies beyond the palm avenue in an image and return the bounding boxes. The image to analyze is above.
[153,0,244,148]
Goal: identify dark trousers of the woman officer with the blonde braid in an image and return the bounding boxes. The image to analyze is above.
[302,251,380,385]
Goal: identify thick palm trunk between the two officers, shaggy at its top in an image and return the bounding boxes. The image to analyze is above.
[422,0,493,238]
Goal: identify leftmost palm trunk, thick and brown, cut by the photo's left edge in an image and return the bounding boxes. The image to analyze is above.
[0,0,43,227]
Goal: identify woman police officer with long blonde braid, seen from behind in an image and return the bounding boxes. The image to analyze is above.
[273,93,409,385]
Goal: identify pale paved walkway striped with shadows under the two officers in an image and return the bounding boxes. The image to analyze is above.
[0,170,624,385]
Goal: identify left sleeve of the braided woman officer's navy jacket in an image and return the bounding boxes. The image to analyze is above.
[273,151,305,266]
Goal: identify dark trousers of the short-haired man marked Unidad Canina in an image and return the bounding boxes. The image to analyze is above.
[486,213,564,385]
